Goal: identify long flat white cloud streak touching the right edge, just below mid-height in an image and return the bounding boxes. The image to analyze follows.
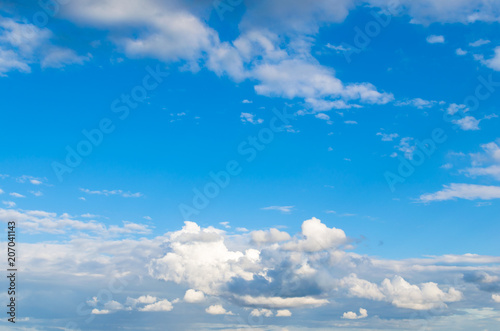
[419,183,500,202]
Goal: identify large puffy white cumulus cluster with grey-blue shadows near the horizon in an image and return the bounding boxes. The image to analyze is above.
[145,217,462,318]
